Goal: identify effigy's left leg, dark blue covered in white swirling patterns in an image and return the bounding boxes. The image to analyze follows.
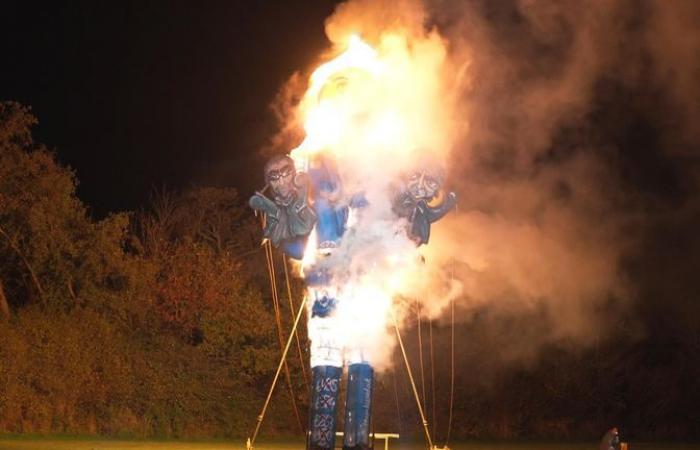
[307,366,343,450]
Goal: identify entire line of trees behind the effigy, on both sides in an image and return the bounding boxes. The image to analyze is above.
[0,102,700,444]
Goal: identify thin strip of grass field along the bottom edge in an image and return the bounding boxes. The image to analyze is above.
[0,436,700,450]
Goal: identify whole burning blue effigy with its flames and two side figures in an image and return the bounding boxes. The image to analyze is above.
[250,34,456,450]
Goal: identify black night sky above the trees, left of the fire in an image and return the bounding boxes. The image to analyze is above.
[0,0,335,216]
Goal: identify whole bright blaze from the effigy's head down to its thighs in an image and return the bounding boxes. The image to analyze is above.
[291,32,456,365]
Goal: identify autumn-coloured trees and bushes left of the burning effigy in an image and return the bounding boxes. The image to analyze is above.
[0,102,308,437]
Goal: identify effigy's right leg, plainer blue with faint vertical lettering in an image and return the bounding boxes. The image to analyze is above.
[343,363,374,450]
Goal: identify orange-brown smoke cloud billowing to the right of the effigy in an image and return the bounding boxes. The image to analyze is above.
[426,0,700,358]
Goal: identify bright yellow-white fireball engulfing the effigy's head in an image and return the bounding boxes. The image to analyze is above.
[291,33,448,168]
